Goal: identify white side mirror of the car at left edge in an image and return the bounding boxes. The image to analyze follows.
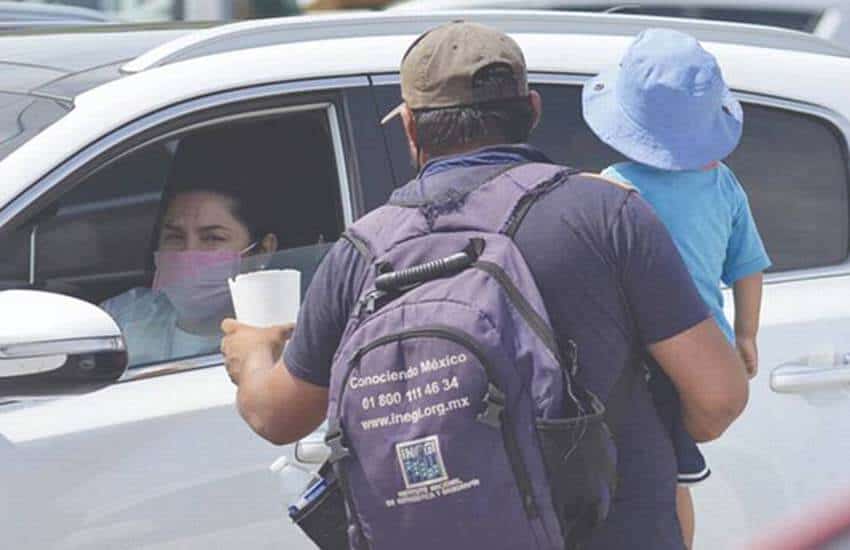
[0,290,127,398]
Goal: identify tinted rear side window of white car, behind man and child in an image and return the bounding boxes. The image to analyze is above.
[376,84,850,272]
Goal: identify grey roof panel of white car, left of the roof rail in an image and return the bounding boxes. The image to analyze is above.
[0,23,214,101]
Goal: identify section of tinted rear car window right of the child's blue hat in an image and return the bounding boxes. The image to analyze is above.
[727,104,850,271]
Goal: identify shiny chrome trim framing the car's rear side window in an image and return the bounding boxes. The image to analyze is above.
[371,71,850,284]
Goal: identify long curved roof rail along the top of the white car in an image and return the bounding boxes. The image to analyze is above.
[124,10,850,72]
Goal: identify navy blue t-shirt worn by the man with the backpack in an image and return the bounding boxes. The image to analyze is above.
[284,146,710,550]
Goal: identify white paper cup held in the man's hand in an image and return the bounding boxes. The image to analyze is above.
[227,269,301,327]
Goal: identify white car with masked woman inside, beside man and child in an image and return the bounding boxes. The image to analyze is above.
[0,12,850,549]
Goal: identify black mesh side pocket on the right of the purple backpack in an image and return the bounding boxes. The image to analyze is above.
[537,395,617,548]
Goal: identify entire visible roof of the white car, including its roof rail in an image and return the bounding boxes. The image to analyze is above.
[0,10,850,103]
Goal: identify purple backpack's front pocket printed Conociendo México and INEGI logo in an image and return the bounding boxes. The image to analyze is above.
[328,326,548,549]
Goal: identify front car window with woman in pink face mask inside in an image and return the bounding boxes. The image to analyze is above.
[0,105,345,368]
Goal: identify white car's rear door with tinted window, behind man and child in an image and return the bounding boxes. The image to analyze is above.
[372,74,850,548]
